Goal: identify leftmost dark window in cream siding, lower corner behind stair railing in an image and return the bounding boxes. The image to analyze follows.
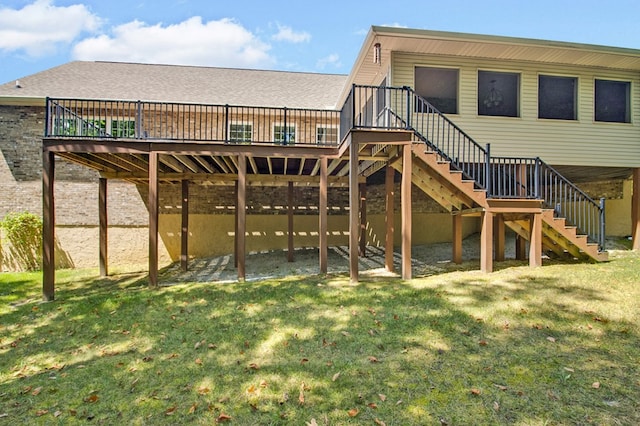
[415,67,458,114]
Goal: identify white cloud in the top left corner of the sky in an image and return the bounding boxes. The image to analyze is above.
[0,0,101,56]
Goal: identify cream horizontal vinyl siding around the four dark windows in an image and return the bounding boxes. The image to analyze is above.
[391,52,640,167]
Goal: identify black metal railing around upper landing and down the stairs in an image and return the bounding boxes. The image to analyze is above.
[340,85,605,250]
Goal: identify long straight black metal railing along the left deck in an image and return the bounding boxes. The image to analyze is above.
[45,98,340,146]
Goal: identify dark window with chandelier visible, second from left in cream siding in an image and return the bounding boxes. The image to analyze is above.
[478,71,520,117]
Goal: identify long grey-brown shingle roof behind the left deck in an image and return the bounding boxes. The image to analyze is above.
[0,61,347,109]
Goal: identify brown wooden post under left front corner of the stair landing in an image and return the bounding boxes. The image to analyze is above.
[349,137,360,283]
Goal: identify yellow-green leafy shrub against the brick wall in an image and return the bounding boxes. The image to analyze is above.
[0,212,42,271]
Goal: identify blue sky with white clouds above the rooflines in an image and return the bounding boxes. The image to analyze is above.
[0,0,640,83]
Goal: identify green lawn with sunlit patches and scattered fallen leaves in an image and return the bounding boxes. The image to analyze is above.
[0,252,640,425]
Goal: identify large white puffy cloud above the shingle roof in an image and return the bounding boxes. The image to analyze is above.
[73,16,273,68]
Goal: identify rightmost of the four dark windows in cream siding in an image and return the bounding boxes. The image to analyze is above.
[595,79,631,123]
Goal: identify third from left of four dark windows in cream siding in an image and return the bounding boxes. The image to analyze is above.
[538,75,578,120]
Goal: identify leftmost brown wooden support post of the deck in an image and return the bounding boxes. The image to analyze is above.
[42,151,56,302]
